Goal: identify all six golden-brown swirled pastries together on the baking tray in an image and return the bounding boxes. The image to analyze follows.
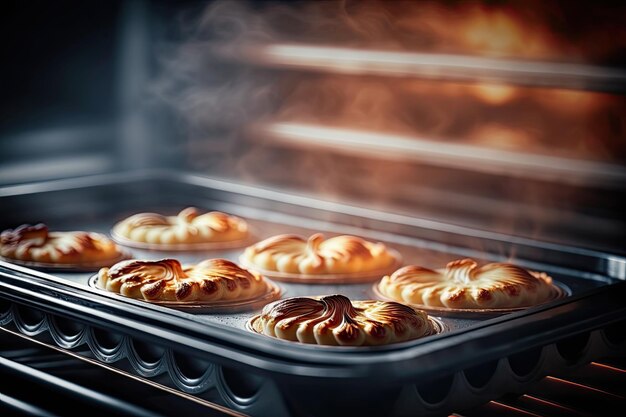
[0,208,555,345]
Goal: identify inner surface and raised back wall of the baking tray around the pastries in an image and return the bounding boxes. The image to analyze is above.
[0,176,624,349]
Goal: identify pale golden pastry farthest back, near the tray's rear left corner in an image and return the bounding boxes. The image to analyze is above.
[113,207,248,245]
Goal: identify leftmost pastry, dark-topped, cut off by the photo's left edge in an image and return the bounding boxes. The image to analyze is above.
[0,223,124,266]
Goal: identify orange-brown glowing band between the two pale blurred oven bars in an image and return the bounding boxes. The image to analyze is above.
[256,70,626,161]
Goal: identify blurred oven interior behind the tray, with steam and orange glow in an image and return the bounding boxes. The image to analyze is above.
[0,0,626,254]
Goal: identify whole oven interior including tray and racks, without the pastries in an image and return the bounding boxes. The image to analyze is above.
[0,0,626,416]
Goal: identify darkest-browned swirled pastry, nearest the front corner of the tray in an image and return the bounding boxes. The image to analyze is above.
[252,295,434,346]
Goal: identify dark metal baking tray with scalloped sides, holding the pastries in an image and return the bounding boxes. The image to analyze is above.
[0,172,626,416]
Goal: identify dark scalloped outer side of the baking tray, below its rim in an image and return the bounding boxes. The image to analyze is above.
[0,288,626,416]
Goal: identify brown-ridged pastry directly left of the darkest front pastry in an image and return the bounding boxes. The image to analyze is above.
[98,259,268,302]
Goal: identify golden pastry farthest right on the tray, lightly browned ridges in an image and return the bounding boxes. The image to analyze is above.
[378,259,557,309]
